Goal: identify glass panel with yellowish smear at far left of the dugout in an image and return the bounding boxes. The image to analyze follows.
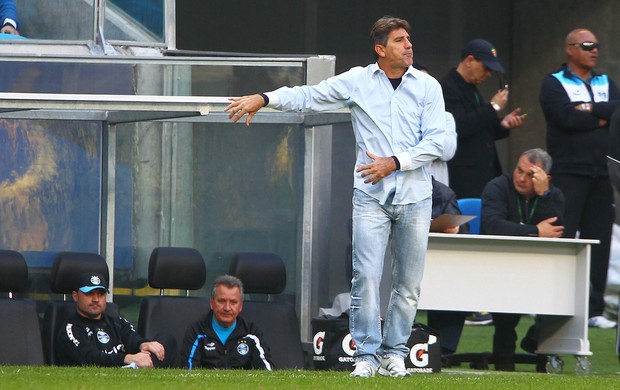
[0,119,101,302]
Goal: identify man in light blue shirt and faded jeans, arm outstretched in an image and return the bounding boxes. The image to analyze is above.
[226,16,446,377]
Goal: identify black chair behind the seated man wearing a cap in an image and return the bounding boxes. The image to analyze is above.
[42,252,119,365]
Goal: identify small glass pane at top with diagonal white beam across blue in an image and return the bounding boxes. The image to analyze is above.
[105,0,165,42]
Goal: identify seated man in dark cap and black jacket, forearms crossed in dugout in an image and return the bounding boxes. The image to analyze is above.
[56,272,176,368]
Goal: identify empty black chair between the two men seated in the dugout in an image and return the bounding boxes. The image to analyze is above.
[138,247,211,367]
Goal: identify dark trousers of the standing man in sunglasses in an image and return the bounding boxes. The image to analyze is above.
[553,174,614,317]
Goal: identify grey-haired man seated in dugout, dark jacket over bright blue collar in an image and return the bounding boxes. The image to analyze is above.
[181,275,277,370]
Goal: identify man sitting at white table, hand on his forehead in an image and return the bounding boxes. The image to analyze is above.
[480,148,564,371]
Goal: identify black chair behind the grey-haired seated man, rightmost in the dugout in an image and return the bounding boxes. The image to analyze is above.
[229,253,305,369]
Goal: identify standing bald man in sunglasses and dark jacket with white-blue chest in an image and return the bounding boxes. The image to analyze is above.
[540,29,620,328]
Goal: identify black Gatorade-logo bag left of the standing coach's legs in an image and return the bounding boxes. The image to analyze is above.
[312,313,355,371]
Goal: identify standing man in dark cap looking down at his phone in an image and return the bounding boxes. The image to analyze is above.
[441,39,524,198]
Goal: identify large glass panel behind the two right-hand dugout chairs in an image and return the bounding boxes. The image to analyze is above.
[115,123,304,316]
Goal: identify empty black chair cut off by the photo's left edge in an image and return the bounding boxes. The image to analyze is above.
[0,250,44,366]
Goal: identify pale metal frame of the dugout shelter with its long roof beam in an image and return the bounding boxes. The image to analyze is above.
[0,0,350,341]
